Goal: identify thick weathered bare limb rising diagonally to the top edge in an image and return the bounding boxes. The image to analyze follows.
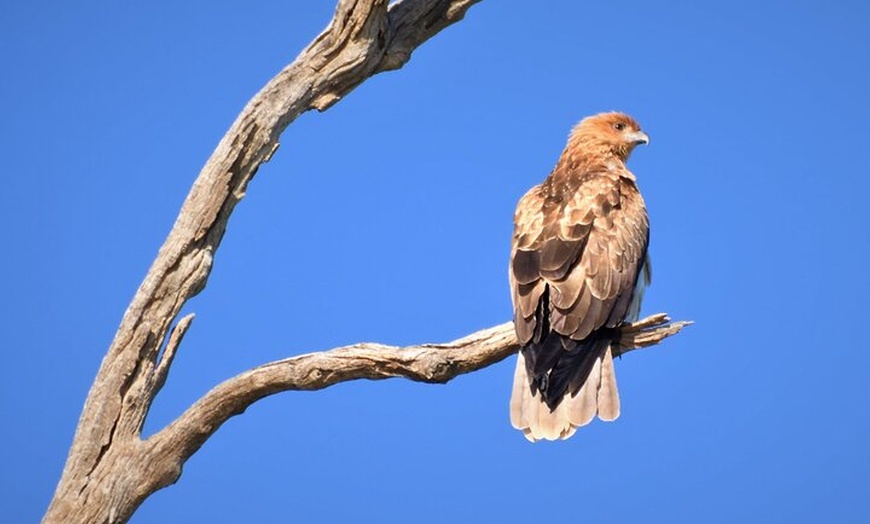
[43,0,479,522]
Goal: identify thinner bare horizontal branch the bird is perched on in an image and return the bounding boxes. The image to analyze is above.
[149,313,691,464]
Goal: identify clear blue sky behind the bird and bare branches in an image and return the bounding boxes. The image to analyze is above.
[0,0,870,524]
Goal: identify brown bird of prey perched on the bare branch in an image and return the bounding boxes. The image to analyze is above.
[509,113,650,442]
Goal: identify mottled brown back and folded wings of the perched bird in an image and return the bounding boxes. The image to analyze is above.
[510,172,649,344]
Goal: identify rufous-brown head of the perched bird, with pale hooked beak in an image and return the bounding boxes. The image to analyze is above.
[568,113,649,161]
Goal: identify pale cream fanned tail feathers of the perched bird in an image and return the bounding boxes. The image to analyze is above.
[510,343,619,442]
